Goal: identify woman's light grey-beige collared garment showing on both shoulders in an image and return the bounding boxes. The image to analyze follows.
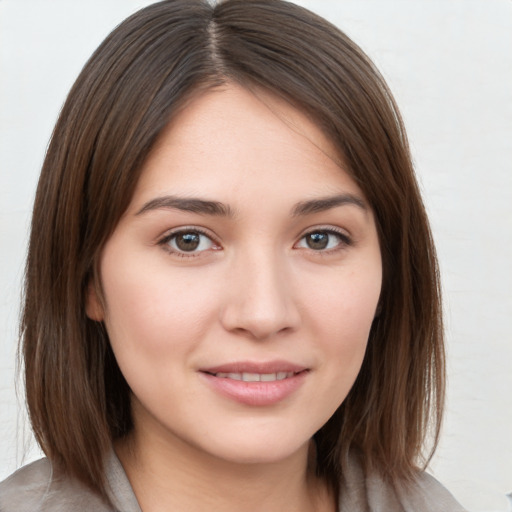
[0,451,465,512]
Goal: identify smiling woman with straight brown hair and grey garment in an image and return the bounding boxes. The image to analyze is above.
[0,0,462,512]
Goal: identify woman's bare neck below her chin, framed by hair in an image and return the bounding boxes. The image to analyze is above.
[116,422,334,512]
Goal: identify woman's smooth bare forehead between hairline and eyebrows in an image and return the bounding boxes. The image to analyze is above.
[128,84,361,211]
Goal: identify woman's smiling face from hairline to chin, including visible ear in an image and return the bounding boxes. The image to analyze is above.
[88,85,382,463]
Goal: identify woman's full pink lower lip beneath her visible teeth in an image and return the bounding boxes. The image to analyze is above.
[201,371,308,406]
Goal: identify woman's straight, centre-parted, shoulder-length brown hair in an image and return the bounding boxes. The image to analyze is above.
[21,0,444,502]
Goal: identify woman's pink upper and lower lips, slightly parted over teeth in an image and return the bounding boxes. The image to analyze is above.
[199,361,309,407]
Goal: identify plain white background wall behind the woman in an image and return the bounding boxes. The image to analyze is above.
[0,0,512,511]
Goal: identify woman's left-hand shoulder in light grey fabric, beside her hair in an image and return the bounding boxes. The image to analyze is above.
[0,458,112,512]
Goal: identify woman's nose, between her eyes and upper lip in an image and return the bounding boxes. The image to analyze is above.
[221,251,301,340]
